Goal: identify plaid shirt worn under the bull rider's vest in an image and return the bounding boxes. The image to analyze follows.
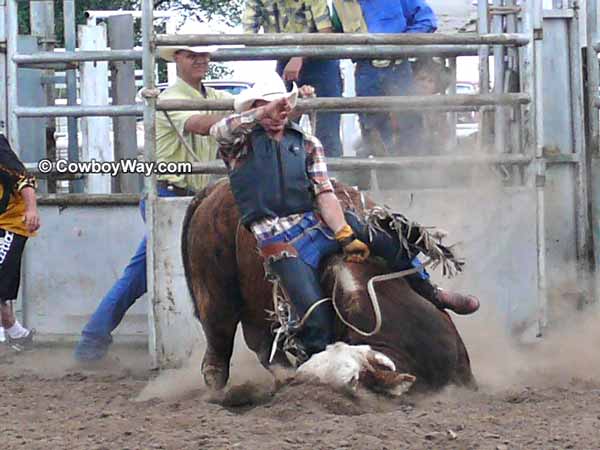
[210,109,333,242]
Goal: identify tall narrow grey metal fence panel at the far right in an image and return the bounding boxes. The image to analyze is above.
[543,17,587,308]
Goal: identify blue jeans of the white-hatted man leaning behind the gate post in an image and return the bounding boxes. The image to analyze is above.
[75,188,175,360]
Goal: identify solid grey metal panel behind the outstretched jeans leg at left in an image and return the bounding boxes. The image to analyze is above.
[22,205,148,341]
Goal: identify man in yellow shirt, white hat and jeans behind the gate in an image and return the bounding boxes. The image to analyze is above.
[74,46,230,362]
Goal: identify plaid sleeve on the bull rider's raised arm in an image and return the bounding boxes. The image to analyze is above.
[210,109,258,169]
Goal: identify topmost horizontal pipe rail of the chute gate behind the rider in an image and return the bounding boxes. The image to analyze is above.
[155,33,529,46]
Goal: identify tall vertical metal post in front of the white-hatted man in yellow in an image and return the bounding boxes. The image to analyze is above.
[142,0,161,367]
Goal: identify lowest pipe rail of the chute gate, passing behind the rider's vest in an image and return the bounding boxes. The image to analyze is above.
[192,154,533,175]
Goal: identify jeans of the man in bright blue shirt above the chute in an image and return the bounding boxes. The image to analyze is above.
[356,60,422,156]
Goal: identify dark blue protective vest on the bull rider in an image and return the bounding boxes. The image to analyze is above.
[229,125,314,225]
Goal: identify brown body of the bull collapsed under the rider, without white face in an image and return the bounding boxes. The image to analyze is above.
[182,182,474,389]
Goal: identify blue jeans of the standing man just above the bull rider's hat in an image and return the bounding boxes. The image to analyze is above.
[277,59,342,157]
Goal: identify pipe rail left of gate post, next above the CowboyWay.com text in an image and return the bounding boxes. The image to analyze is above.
[14,105,144,117]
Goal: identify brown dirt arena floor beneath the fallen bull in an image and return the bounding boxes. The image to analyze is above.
[0,310,600,450]
